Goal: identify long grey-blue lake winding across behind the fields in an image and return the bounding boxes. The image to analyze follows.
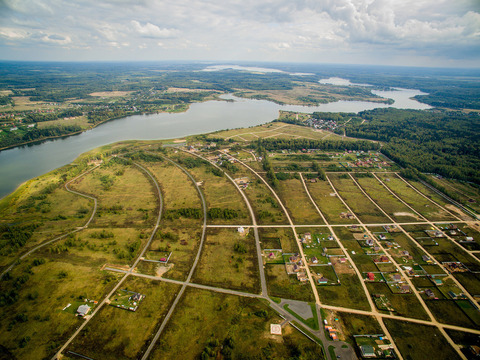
[0,89,430,198]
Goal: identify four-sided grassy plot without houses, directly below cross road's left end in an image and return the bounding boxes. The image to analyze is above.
[194,228,260,293]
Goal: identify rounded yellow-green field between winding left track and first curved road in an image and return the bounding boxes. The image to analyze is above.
[71,161,158,227]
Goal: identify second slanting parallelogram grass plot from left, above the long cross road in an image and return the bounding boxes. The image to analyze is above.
[328,174,390,223]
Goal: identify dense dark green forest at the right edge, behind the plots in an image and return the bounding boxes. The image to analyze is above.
[345,108,480,184]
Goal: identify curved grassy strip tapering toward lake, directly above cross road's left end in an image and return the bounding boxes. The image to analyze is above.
[171,152,253,224]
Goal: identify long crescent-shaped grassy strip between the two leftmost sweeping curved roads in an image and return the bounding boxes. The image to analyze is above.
[137,161,203,280]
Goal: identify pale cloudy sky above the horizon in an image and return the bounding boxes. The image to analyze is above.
[0,0,480,67]
